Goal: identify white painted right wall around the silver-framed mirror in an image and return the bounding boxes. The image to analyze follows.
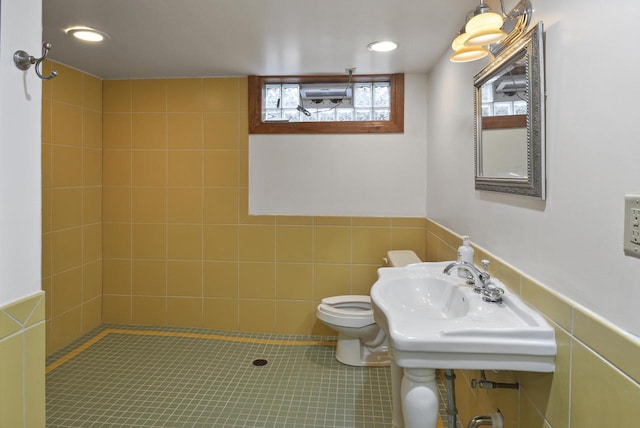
[427,0,640,336]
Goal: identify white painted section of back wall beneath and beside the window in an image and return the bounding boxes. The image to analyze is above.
[249,75,427,217]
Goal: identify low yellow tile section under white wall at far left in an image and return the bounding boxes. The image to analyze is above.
[0,292,45,427]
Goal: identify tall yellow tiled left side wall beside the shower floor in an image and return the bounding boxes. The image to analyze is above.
[42,63,102,353]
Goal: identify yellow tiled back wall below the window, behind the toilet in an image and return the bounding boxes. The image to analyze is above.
[102,78,425,334]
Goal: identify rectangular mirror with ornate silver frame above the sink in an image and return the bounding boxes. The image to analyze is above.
[474,22,545,199]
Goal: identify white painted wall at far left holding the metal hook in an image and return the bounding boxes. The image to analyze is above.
[0,0,42,307]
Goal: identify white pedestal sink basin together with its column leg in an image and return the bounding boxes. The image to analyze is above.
[371,262,556,428]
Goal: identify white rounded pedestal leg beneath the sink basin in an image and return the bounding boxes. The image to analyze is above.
[391,362,438,428]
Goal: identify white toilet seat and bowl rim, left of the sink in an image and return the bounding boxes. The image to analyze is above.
[318,295,375,328]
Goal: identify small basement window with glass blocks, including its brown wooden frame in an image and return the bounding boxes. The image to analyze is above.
[247,73,404,134]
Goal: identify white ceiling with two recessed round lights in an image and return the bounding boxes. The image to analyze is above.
[42,0,477,79]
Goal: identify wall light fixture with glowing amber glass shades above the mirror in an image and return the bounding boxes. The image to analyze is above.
[449,0,533,62]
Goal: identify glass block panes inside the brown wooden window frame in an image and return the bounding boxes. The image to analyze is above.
[263,82,391,122]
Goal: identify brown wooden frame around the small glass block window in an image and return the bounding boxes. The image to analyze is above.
[249,74,404,134]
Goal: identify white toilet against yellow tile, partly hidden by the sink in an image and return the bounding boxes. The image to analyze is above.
[316,250,421,366]
